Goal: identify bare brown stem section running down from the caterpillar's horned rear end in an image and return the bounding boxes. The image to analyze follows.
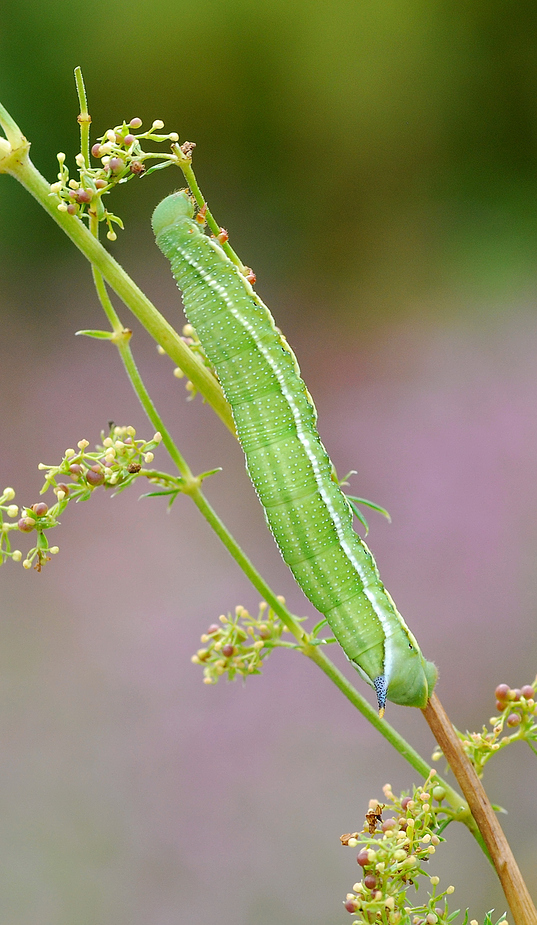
[422,693,537,925]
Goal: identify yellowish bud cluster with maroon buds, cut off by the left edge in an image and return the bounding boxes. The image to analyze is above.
[0,427,162,571]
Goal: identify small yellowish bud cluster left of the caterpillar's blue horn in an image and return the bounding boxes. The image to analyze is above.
[192,598,293,684]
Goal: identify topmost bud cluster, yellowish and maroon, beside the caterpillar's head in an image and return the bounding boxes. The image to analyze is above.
[50,118,181,241]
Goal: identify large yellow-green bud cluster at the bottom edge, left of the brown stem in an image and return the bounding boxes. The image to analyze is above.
[341,770,506,925]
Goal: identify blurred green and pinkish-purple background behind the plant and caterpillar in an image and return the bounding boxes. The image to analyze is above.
[0,0,537,925]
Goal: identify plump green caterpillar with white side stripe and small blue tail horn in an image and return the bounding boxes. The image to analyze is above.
[152,190,437,715]
